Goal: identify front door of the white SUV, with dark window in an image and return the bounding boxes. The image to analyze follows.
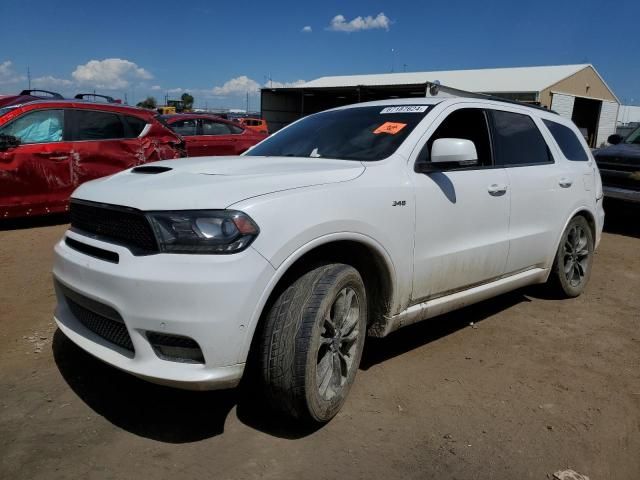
[412,106,510,303]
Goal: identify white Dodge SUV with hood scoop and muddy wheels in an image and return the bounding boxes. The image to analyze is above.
[53,98,604,422]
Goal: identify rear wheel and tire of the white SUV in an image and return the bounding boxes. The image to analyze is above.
[548,216,594,298]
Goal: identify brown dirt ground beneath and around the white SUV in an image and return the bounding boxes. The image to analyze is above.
[0,200,640,480]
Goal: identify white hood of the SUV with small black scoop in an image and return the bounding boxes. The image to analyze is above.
[72,156,365,210]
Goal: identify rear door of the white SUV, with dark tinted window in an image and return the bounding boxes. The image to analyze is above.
[490,107,568,273]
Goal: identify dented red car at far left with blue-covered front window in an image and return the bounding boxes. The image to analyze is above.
[0,97,185,219]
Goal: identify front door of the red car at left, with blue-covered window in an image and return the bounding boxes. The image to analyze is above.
[0,109,74,216]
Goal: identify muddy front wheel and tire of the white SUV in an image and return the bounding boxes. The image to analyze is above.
[259,264,367,423]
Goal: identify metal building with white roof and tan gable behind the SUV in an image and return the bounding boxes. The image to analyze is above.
[261,64,620,147]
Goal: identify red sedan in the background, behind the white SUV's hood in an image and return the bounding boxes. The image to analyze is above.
[162,113,267,157]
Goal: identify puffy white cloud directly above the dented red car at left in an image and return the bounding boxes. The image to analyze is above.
[71,58,153,90]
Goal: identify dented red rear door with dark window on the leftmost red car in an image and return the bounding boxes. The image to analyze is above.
[67,109,146,185]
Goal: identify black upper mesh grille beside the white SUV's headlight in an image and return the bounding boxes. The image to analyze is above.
[69,200,159,255]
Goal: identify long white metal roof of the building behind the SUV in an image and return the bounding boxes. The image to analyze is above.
[298,64,595,92]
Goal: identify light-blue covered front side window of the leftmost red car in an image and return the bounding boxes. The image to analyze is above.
[0,110,64,143]
